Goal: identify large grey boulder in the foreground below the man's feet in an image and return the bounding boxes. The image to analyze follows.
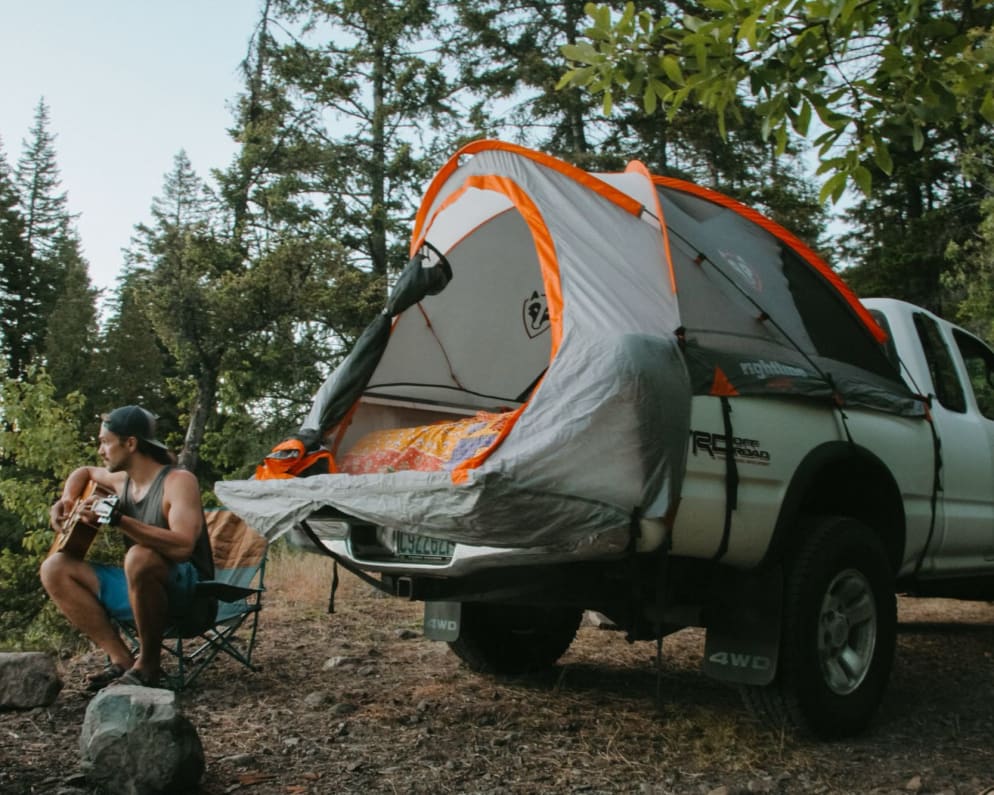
[79,685,204,795]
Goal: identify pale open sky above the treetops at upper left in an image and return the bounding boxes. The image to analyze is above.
[0,0,259,291]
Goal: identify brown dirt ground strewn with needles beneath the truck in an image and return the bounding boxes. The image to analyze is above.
[0,555,994,795]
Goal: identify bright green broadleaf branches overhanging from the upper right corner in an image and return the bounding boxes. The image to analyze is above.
[562,0,994,200]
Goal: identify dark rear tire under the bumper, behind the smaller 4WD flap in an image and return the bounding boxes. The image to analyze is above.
[449,602,583,675]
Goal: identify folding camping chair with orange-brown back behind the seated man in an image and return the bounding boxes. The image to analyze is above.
[115,508,267,690]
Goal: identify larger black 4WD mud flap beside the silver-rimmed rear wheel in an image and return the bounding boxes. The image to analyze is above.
[704,566,783,686]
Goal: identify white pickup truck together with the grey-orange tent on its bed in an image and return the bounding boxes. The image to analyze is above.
[215,141,994,737]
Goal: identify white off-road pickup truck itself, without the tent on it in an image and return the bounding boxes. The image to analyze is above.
[280,299,994,737]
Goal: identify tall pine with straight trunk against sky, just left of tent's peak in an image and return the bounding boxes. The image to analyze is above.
[262,0,451,277]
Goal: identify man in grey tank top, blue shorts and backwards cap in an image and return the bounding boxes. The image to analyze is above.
[41,406,216,690]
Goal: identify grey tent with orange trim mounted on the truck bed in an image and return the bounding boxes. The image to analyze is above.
[216,141,921,557]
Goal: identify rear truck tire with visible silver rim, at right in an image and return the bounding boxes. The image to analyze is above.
[742,517,897,739]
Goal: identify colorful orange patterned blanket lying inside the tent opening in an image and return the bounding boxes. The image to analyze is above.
[338,411,512,475]
